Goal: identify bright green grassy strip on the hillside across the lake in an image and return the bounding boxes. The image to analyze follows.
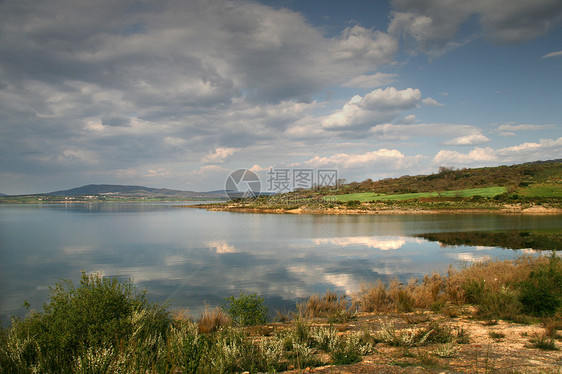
[331,187,507,202]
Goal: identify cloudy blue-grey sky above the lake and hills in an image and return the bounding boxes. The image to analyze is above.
[0,0,562,194]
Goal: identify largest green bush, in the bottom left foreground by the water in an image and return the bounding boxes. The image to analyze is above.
[2,273,170,372]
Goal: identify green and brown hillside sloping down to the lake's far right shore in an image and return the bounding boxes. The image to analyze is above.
[189,160,562,214]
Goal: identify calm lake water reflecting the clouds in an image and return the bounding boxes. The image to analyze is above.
[0,203,562,326]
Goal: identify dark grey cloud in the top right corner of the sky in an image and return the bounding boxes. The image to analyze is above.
[388,0,562,55]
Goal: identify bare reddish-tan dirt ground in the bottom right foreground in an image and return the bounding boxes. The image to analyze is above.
[278,312,562,374]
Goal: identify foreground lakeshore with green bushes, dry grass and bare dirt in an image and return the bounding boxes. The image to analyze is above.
[0,253,562,373]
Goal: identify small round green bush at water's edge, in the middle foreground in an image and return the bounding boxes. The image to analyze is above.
[223,291,267,326]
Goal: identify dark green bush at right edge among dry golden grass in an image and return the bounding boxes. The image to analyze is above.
[520,254,562,317]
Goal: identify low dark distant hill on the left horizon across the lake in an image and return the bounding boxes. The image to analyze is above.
[44,184,217,198]
